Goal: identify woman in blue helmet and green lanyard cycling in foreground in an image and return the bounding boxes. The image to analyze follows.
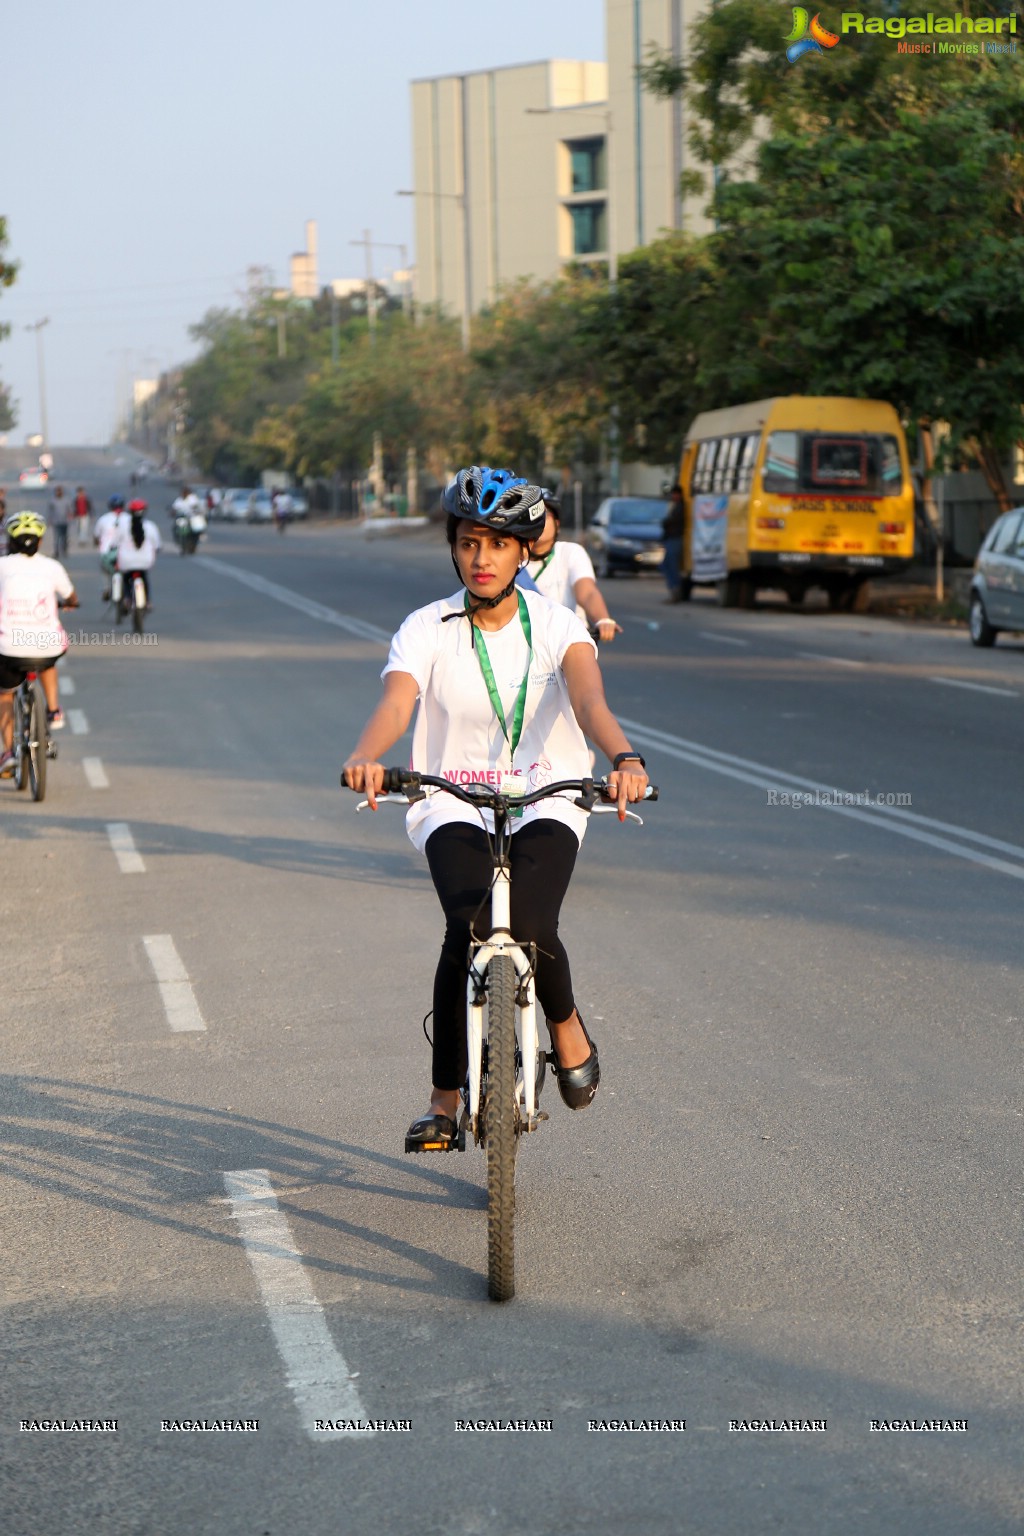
[344,467,648,1143]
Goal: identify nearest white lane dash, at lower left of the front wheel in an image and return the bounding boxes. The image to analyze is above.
[224,1167,373,1441]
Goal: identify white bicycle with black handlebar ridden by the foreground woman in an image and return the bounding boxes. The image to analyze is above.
[342,768,657,1301]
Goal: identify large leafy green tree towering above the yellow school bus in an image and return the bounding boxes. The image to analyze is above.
[646,0,1024,505]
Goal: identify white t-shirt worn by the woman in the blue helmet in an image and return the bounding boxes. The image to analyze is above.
[381,590,596,852]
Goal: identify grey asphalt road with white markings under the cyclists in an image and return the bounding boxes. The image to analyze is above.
[0,453,1024,1536]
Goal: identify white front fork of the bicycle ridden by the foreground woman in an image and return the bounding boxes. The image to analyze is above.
[467,859,547,1141]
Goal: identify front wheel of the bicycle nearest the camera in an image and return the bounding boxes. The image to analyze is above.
[484,955,519,1301]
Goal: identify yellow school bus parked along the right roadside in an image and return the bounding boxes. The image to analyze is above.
[679,395,913,611]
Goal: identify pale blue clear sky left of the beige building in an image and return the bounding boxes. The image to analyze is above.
[0,0,605,448]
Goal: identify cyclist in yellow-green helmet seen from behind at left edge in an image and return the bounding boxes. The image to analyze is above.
[0,511,78,779]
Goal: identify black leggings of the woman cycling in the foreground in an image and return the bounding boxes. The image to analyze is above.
[427,819,579,1089]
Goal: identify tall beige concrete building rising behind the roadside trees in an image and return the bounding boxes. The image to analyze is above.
[411,0,706,319]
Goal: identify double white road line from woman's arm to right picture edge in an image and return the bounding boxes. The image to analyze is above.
[619,714,1024,880]
